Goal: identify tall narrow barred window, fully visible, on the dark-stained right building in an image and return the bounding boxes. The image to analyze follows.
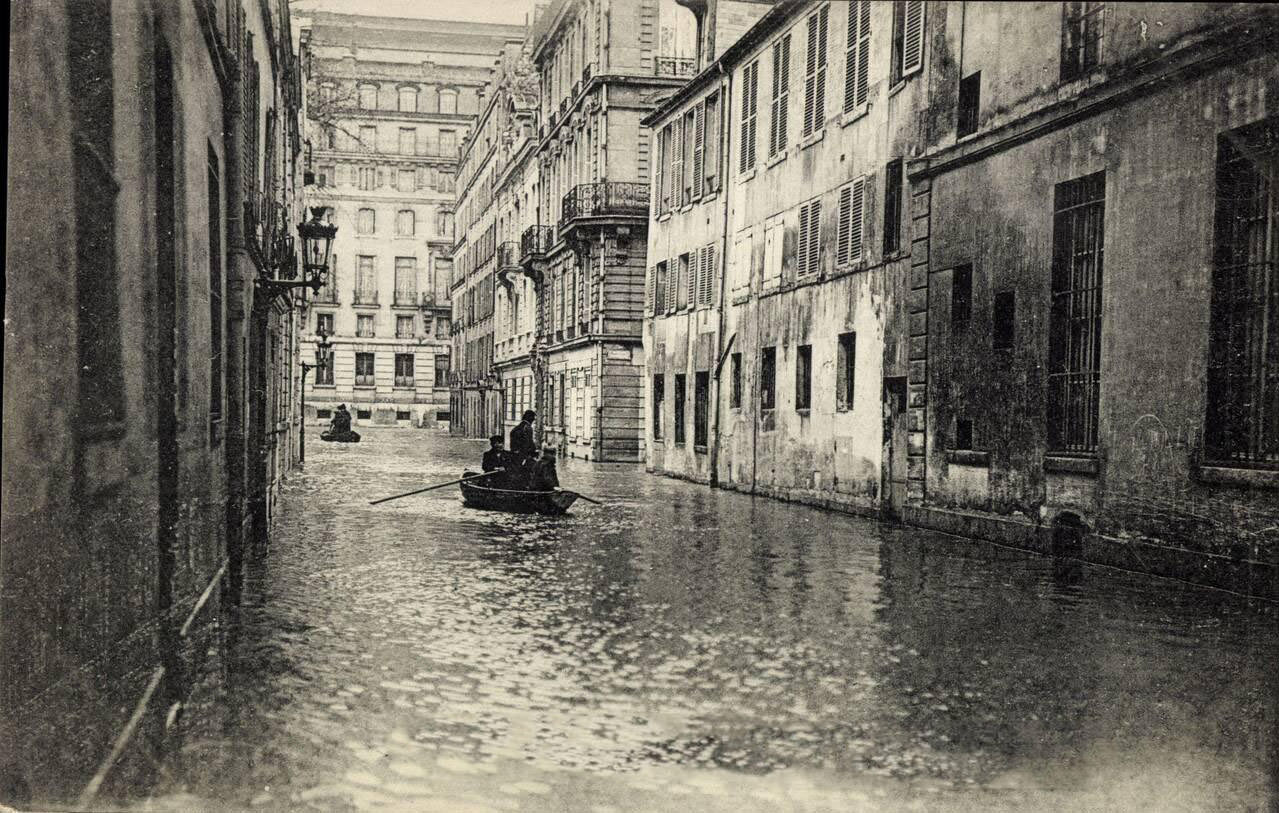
[1053,173,1106,454]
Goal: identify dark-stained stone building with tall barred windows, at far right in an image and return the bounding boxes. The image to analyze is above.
[907,3,1279,597]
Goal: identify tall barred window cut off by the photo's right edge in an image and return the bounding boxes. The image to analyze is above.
[1205,116,1279,468]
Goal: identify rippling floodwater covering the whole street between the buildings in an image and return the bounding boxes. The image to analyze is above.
[137,427,1279,813]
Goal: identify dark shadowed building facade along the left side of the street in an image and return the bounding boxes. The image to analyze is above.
[0,0,302,808]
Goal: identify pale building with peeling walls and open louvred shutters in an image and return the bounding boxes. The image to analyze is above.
[645,1,925,514]
